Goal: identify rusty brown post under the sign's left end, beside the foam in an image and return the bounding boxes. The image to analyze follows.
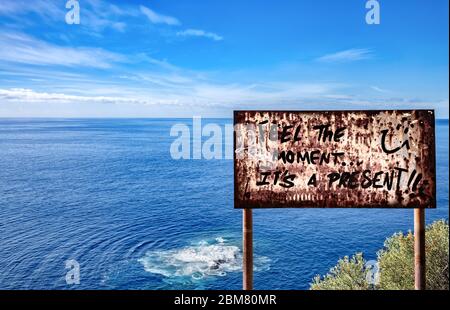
[242,209,253,290]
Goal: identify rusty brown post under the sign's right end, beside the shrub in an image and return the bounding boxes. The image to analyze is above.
[414,208,426,290]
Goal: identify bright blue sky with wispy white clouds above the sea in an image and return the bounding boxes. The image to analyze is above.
[0,0,449,118]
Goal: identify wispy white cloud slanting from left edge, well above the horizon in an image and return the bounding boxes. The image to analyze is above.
[0,32,126,68]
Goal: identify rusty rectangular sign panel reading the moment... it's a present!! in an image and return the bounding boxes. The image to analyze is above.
[234,110,436,208]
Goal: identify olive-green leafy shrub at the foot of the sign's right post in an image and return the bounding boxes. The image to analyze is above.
[311,220,449,290]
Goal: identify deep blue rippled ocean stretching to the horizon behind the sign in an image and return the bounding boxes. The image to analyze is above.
[0,119,449,289]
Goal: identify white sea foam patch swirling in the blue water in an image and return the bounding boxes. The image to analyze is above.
[138,237,270,280]
